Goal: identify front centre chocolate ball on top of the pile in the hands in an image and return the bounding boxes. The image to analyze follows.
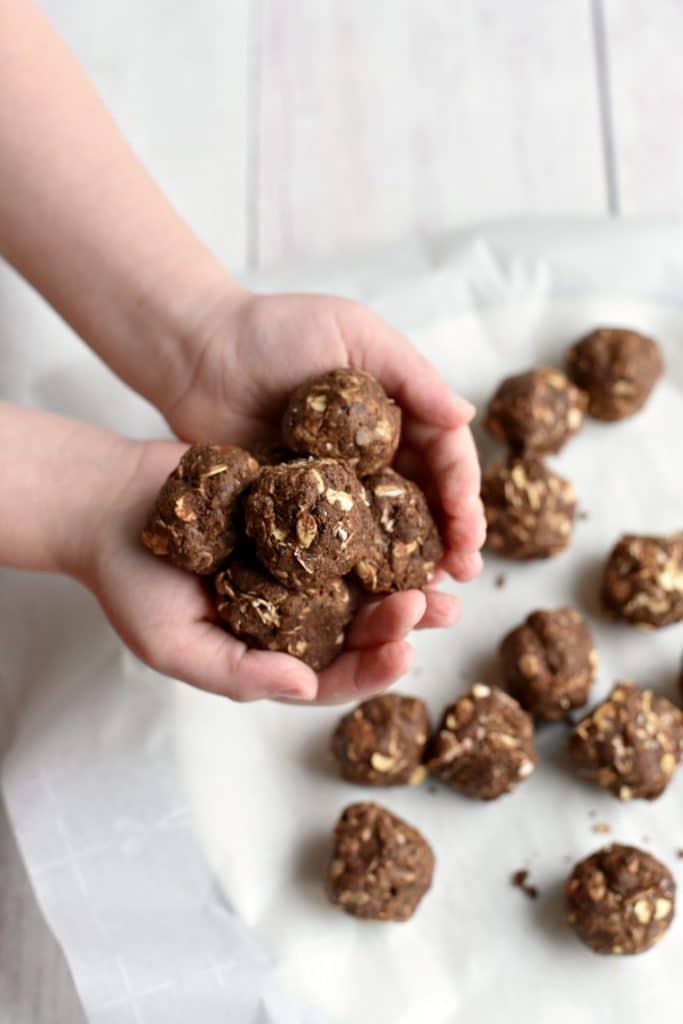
[245,459,374,587]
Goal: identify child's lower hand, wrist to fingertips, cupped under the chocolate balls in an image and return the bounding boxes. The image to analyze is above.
[87,441,457,703]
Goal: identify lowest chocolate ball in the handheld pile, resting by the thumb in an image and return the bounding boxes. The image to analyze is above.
[216,558,352,672]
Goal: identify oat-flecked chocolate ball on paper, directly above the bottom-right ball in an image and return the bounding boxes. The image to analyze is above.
[569,682,683,800]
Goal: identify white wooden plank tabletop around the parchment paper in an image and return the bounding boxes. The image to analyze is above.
[0,0,683,1024]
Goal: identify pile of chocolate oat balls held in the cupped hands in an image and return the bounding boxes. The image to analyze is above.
[142,368,443,671]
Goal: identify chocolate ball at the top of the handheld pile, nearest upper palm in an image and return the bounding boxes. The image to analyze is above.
[283,367,400,476]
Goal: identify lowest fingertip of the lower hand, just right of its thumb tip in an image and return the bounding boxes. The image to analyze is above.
[315,640,415,705]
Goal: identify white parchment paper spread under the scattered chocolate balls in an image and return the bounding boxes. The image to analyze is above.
[0,223,683,1024]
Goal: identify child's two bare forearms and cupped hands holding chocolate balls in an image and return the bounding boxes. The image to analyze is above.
[0,2,484,700]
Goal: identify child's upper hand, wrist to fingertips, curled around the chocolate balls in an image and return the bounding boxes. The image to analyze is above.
[162,292,484,585]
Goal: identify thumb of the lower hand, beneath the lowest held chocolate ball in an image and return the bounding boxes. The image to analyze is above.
[151,622,317,700]
